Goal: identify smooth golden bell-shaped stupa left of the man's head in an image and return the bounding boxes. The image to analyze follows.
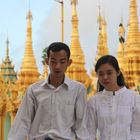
[17,10,39,91]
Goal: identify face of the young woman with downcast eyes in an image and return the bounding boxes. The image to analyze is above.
[97,63,119,91]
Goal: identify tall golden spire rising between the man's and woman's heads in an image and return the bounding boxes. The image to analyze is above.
[67,0,91,92]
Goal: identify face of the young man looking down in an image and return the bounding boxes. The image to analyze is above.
[46,50,71,78]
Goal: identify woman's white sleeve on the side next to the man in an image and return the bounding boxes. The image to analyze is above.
[87,97,98,140]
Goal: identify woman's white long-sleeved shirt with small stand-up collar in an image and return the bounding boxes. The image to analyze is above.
[88,87,140,140]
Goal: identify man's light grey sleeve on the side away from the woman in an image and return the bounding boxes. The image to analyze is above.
[8,87,35,140]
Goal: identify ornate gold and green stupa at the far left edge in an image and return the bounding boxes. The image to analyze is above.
[0,39,20,140]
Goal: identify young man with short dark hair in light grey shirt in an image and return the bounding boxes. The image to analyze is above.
[8,42,88,140]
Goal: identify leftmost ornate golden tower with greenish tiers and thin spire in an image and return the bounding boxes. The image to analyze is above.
[0,38,17,140]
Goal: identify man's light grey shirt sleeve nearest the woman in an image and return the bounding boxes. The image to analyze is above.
[74,86,89,140]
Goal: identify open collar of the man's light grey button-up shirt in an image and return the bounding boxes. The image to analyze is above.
[41,76,70,88]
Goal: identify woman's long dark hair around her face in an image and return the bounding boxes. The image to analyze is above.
[95,55,126,91]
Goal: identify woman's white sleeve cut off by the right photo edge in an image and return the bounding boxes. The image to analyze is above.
[132,94,140,140]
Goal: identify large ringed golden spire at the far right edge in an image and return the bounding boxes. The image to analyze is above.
[125,0,140,89]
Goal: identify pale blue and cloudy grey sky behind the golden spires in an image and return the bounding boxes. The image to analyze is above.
[0,0,140,74]
